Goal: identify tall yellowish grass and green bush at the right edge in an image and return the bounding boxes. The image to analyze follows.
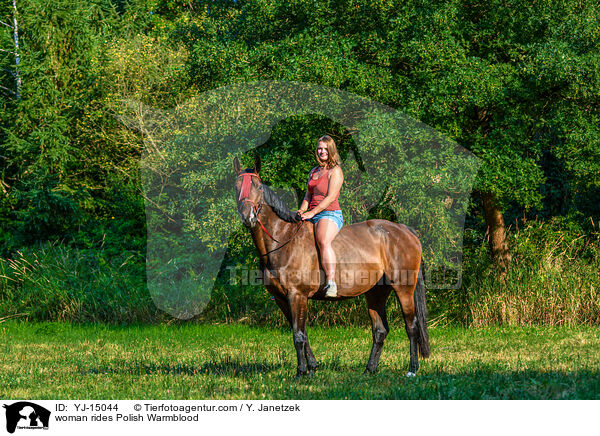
[465,217,600,326]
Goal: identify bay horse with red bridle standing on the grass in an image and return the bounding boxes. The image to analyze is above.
[233,158,430,377]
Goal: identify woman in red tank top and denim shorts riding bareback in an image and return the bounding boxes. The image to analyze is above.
[297,135,344,297]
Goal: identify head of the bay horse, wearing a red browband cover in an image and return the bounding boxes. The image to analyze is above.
[233,157,264,228]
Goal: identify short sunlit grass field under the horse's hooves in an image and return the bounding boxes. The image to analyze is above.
[0,322,600,399]
